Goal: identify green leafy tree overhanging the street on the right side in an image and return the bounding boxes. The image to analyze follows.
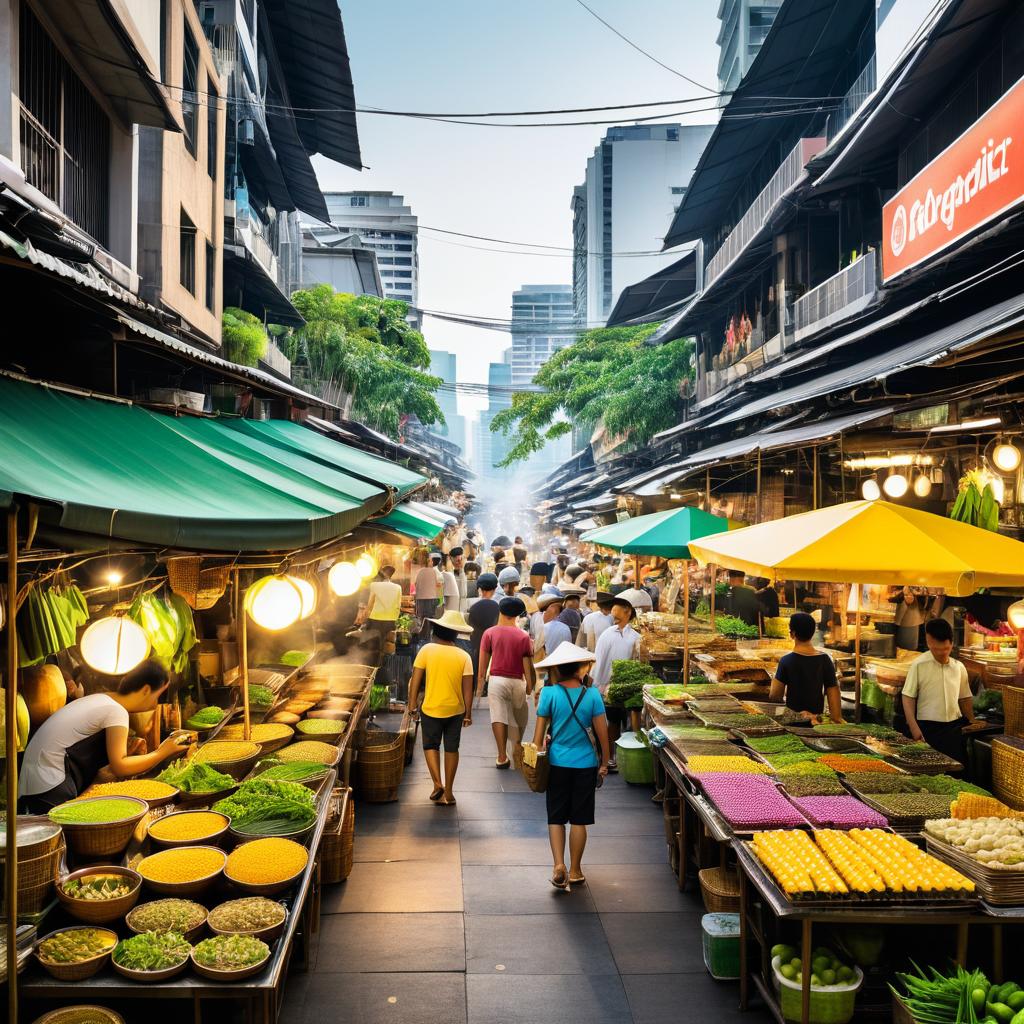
[490,324,693,466]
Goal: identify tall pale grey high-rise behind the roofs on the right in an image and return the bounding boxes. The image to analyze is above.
[571,125,714,328]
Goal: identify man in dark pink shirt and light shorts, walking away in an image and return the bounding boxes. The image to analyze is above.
[476,597,536,768]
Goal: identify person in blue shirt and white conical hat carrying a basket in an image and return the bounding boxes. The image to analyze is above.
[534,643,610,890]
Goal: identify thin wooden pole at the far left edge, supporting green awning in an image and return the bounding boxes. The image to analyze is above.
[4,505,17,1024]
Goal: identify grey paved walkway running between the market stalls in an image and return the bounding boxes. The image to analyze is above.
[282,709,768,1024]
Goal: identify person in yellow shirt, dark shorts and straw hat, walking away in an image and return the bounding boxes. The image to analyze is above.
[409,610,473,807]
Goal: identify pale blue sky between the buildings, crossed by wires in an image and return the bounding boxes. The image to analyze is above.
[315,0,719,425]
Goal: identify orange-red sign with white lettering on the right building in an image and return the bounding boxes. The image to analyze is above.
[882,72,1024,282]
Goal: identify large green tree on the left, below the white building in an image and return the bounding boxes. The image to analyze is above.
[285,285,444,437]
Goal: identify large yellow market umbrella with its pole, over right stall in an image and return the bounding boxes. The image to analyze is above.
[690,501,1024,717]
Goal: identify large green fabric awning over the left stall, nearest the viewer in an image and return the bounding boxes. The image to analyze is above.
[0,377,388,551]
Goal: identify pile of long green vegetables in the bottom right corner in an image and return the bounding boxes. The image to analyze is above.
[890,964,1024,1024]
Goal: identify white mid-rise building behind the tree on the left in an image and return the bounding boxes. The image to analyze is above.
[317,191,420,327]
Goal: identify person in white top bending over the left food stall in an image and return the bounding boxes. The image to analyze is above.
[18,660,184,814]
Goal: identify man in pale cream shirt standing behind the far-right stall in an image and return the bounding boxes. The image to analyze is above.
[902,618,974,764]
